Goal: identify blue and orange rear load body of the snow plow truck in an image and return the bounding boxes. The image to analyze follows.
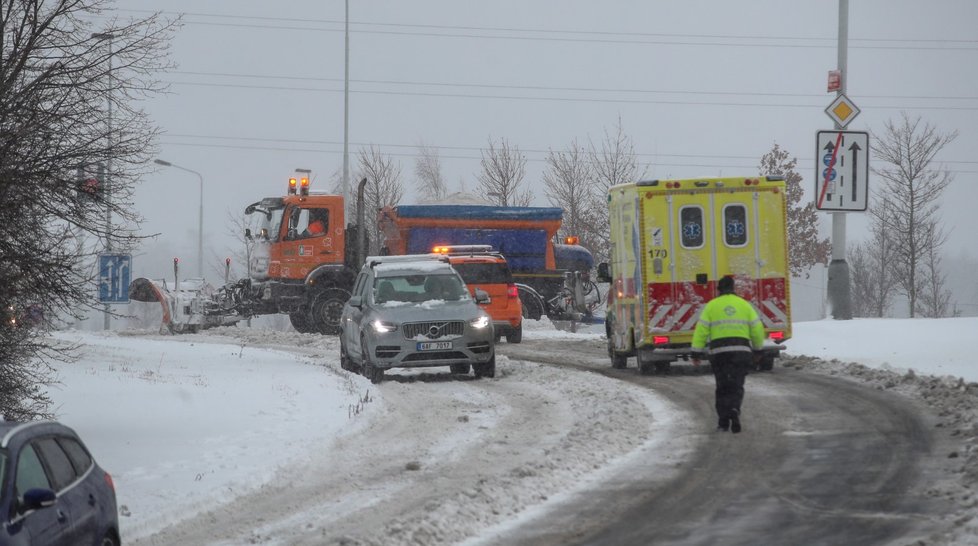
[378,205,600,321]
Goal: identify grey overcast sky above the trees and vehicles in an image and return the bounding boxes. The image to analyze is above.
[116,0,978,278]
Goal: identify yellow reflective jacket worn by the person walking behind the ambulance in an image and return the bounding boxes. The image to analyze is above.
[693,294,764,354]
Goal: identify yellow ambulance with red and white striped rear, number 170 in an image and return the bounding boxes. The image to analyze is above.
[598,176,791,373]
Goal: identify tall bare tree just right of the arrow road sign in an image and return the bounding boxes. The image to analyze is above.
[873,114,957,317]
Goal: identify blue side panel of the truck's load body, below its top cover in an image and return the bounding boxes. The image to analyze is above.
[407,225,559,273]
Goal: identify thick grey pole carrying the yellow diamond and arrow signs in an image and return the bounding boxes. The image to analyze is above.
[828,0,852,320]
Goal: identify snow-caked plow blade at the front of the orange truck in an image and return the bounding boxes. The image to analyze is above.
[129,277,243,334]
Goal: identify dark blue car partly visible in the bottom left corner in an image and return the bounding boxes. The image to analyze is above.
[0,421,119,546]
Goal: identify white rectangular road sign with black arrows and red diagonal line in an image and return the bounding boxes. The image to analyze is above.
[815,131,869,211]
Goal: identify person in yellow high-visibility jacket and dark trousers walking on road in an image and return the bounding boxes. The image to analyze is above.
[692,276,764,432]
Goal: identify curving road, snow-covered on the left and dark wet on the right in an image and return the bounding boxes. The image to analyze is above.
[114,328,959,545]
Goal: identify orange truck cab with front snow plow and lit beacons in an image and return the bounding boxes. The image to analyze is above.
[129,172,366,334]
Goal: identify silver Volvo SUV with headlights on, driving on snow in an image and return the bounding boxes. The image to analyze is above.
[340,255,496,383]
